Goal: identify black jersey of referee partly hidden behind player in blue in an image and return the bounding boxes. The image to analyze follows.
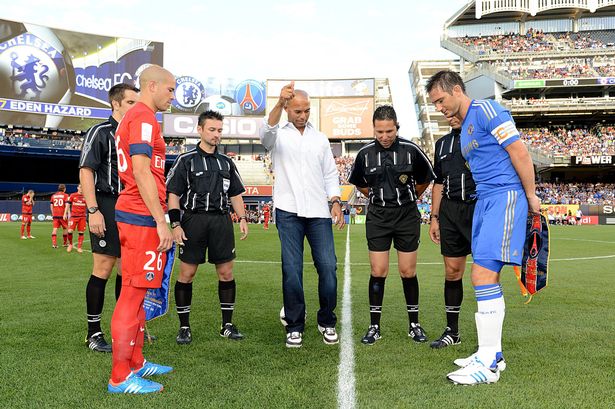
[434,130,476,202]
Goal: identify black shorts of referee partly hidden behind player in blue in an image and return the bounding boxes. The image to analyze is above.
[439,197,476,257]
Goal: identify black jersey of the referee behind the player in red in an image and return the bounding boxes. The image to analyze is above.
[79,116,122,195]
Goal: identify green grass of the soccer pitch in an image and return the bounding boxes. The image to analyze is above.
[0,223,615,408]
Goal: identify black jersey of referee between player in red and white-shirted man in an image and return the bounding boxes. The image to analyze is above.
[167,145,246,213]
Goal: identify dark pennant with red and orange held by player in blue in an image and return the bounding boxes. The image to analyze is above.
[514,214,549,304]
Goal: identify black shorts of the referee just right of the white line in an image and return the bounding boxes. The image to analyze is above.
[365,203,421,253]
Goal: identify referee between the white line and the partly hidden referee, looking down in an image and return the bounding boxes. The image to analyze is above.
[349,106,435,345]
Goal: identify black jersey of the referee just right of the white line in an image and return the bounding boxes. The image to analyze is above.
[348,137,435,207]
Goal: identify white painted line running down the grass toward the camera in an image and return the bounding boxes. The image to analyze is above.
[337,225,357,409]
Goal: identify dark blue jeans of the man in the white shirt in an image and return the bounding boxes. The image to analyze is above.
[276,209,337,332]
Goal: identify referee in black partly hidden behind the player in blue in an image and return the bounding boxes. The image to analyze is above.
[429,117,476,348]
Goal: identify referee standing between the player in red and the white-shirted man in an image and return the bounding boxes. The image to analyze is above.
[167,111,248,344]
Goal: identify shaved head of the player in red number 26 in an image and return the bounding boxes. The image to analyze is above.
[139,65,175,112]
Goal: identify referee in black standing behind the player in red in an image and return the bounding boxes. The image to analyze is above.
[79,84,139,352]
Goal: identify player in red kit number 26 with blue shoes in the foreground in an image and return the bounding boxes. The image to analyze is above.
[107,65,175,394]
